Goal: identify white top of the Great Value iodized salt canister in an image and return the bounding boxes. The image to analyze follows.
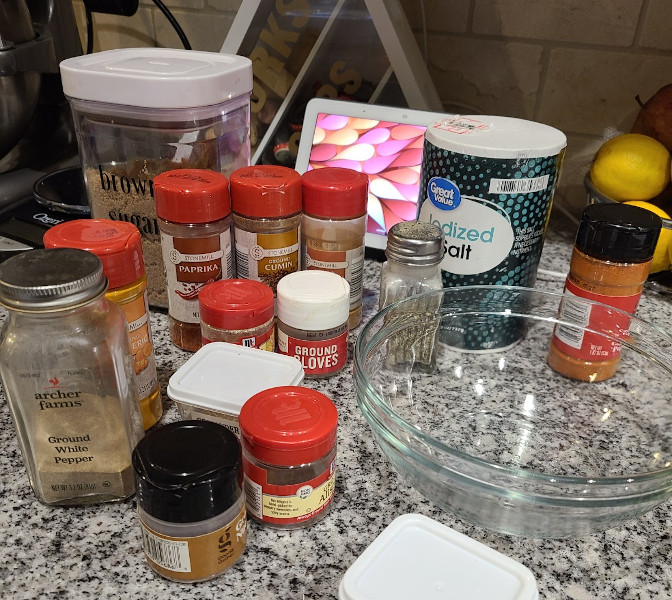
[425,115,567,158]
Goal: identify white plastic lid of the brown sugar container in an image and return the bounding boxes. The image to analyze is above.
[60,48,252,108]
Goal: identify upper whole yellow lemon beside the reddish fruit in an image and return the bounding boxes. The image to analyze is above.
[590,133,670,202]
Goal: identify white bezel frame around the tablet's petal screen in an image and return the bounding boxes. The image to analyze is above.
[294,98,448,250]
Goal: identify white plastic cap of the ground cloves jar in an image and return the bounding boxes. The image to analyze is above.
[276,269,350,331]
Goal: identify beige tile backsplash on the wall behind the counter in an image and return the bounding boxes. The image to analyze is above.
[73,0,672,223]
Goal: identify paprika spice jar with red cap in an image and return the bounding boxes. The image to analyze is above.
[154,169,234,352]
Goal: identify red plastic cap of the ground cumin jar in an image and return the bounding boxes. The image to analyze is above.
[231,165,301,218]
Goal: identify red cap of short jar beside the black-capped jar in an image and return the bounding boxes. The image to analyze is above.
[238,385,338,466]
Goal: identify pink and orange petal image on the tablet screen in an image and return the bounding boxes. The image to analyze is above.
[308,113,426,236]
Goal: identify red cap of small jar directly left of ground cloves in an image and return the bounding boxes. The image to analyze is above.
[198,279,273,329]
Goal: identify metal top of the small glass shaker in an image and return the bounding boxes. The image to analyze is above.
[385,221,444,266]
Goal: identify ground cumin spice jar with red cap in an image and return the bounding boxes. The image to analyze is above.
[231,165,301,294]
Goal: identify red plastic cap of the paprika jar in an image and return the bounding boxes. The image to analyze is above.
[154,169,231,223]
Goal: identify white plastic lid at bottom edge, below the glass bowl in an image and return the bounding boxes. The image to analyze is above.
[338,514,539,600]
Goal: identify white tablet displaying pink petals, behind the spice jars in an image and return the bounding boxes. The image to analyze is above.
[295,98,447,250]
